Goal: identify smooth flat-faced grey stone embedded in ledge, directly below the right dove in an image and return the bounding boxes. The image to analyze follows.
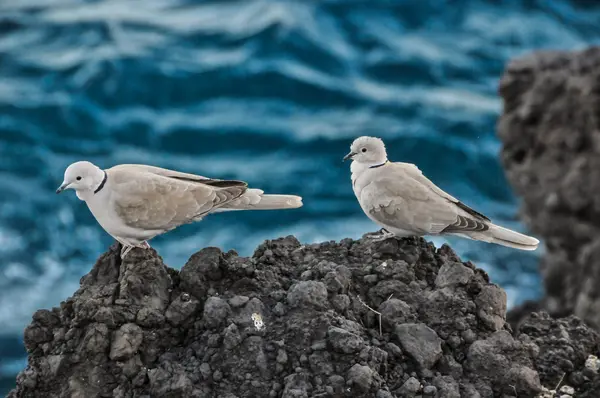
[395,323,442,369]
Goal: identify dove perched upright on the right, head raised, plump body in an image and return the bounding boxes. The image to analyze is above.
[344,137,539,250]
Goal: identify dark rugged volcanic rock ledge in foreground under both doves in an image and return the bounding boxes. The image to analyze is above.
[9,237,600,398]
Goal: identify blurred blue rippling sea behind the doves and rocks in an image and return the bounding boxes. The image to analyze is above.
[0,0,600,395]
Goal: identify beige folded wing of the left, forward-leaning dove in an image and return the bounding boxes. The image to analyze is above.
[107,168,246,231]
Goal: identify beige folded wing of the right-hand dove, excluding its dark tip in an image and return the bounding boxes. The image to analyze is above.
[360,177,458,235]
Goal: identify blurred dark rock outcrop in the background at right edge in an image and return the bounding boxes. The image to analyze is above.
[498,47,600,330]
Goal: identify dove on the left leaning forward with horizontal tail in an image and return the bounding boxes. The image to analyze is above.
[56,161,302,258]
